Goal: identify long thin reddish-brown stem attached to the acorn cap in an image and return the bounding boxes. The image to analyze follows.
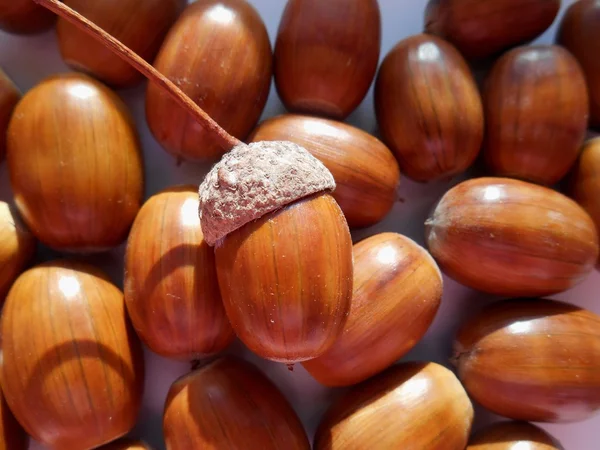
[34,0,241,151]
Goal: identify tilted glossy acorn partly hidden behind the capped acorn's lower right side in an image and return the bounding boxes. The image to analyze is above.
[303,233,443,386]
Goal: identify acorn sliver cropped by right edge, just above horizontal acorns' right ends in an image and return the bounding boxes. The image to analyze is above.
[569,138,600,264]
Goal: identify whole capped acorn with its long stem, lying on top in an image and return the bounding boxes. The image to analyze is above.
[36,0,352,364]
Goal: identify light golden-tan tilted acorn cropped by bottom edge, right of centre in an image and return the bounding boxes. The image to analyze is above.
[314,362,473,450]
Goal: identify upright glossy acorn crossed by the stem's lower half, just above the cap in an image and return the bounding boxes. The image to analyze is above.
[146,0,272,161]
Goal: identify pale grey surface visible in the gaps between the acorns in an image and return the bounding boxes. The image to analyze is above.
[0,0,600,450]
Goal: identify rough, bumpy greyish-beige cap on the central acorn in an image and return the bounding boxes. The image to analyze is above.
[199,141,335,245]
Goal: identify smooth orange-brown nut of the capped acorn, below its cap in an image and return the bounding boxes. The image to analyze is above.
[215,193,353,364]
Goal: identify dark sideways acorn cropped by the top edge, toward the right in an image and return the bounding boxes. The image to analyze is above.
[425,0,561,59]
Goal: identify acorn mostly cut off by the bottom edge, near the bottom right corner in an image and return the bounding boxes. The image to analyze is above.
[466,421,563,450]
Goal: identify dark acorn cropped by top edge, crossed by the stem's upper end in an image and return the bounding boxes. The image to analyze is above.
[56,0,186,88]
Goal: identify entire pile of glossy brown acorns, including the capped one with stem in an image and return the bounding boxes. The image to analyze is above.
[0,0,600,450]
